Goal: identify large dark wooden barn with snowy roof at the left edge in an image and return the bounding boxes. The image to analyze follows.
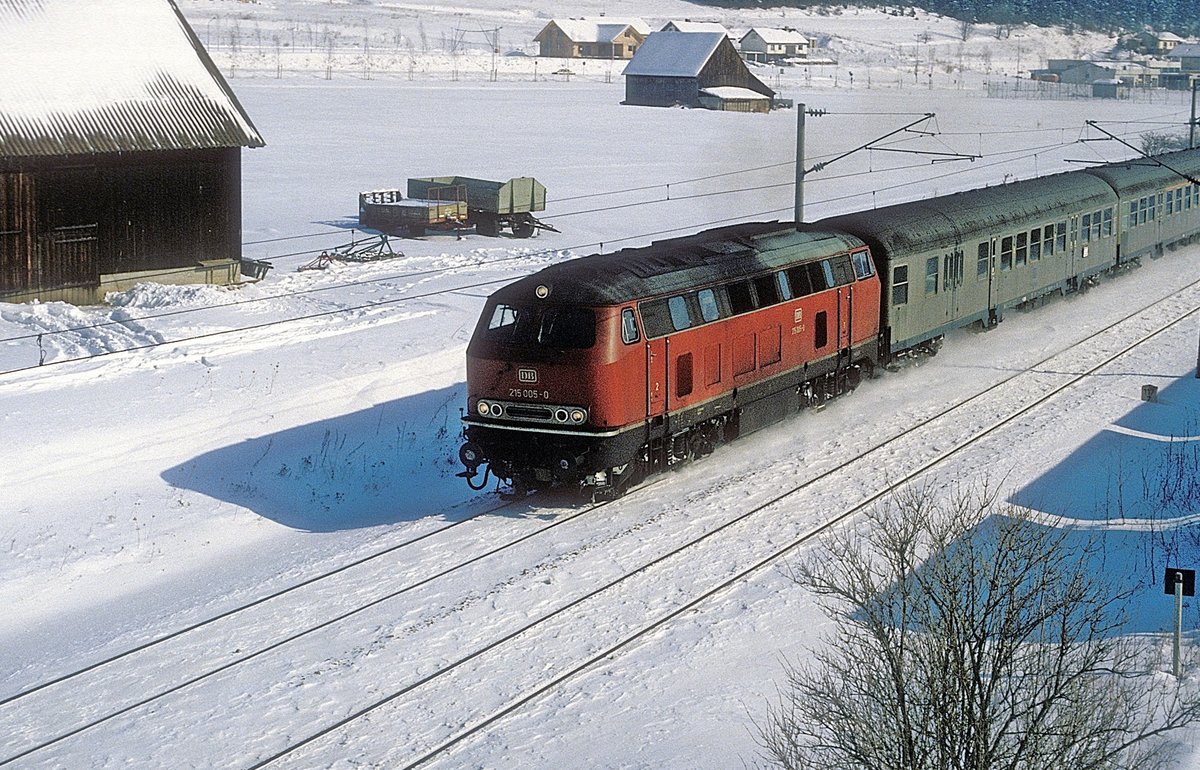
[0,0,263,303]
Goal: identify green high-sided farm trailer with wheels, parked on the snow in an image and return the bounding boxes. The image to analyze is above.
[408,176,549,237]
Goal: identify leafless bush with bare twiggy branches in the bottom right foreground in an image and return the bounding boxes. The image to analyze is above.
[757,489,1200,770]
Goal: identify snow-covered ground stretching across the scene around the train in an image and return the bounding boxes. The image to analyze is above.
[0,0,1200,768]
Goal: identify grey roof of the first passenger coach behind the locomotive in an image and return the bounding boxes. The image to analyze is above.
[816,172,1115,257]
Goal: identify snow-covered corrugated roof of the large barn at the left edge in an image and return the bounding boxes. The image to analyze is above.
[0,0,264,157]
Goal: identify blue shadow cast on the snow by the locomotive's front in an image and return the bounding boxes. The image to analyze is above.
[162,383,529,533]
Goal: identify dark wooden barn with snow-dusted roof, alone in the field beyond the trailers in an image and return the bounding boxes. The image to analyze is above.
[624,32,775,109]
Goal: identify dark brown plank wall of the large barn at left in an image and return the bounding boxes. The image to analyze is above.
[0,149,241,299]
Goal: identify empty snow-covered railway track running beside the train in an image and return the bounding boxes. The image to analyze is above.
[243,282,1200,769]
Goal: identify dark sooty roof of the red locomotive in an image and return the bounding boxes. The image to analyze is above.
[493,222,863,306]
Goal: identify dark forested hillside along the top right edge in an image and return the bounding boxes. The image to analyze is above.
[694,0,1200,36]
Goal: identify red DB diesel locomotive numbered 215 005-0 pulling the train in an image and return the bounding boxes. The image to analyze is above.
[460,223,881,497]
